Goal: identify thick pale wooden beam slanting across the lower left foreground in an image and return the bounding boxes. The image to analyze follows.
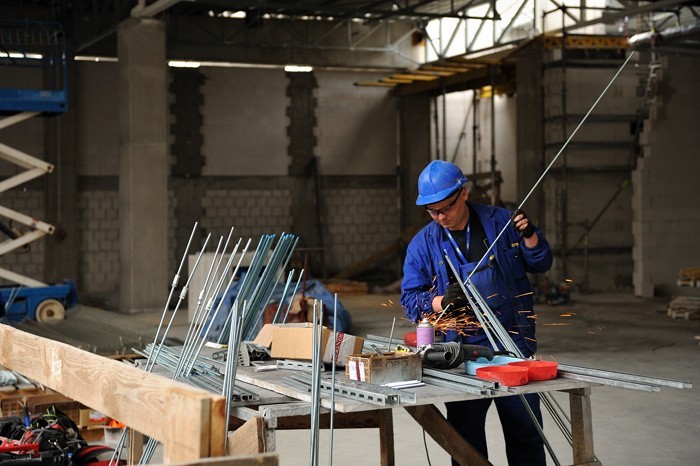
[0,325,224,461]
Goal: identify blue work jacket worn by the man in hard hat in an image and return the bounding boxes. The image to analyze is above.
[401,202,552,356]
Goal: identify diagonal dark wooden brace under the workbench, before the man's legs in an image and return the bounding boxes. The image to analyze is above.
[404,405,491,466]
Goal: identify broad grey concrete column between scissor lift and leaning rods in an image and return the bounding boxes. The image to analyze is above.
[118,18,168,311]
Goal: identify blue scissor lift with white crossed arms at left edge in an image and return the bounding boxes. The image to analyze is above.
[0,20,76,321]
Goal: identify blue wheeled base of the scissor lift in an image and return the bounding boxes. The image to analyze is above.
[0,280,78,322]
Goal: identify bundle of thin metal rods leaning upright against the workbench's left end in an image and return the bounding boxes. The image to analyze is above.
[110,223,301,464]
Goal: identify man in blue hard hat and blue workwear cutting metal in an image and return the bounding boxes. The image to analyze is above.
[401,160,552,465]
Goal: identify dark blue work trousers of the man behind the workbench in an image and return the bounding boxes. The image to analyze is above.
[445,394,546,466]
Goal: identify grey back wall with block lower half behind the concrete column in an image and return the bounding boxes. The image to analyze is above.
[9,62,399,307]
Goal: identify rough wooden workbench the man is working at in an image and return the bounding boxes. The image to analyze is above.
[229,362,600,466]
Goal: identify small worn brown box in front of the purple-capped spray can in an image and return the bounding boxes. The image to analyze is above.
[345,353,423,385]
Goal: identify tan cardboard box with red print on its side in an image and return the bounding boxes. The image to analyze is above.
[266,322,365,366]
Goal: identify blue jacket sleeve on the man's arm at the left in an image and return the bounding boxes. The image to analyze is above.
[401,238,437,322]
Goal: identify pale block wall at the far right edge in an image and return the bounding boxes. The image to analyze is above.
[632,55,700,297]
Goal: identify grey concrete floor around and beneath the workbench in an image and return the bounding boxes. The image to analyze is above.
[268,293,700,466]
